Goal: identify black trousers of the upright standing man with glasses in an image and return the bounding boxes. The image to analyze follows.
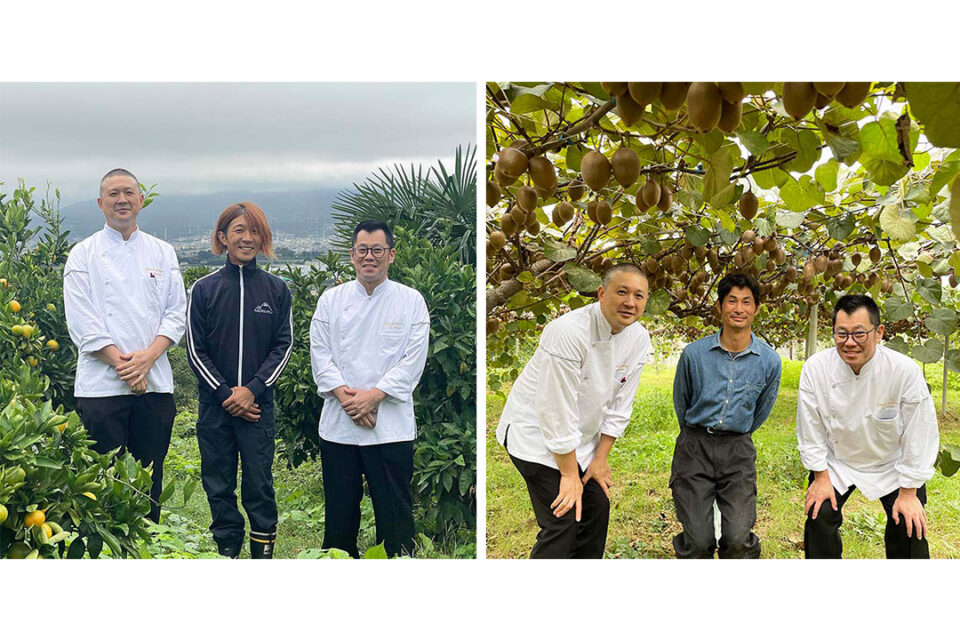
[320,438,414,558]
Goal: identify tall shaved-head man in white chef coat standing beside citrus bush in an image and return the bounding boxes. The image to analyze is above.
[63,169,186,522]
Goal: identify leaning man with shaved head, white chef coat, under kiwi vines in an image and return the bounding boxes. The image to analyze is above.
[497,264,650,558]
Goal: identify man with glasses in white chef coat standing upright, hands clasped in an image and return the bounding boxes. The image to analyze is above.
[310,220,430,557]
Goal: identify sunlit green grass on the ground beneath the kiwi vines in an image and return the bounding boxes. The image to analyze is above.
[486,360,960,558]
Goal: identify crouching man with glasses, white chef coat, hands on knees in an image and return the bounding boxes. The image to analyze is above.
[797,295,939,558]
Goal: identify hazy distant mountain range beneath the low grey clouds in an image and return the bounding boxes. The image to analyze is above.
[60,189,341,241]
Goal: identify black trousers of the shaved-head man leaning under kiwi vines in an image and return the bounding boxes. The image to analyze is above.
[510,456,610,559]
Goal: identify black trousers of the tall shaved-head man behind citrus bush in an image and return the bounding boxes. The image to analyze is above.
[77,393,177,522]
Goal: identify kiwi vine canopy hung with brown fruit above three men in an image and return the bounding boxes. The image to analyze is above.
[486,82,960,472]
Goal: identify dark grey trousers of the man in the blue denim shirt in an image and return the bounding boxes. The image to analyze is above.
[670,426,760,558]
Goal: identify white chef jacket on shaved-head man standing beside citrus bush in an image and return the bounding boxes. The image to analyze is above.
[63,225,187,398]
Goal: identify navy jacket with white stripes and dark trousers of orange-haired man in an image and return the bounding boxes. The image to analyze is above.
[187,260,293,544]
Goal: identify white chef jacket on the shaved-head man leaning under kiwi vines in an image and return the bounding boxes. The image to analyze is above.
[497,302,650,469]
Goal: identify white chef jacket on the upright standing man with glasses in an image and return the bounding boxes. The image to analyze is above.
[310,279,430,446]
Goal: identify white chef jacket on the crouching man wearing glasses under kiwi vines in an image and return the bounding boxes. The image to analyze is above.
[797,345,940,500]
